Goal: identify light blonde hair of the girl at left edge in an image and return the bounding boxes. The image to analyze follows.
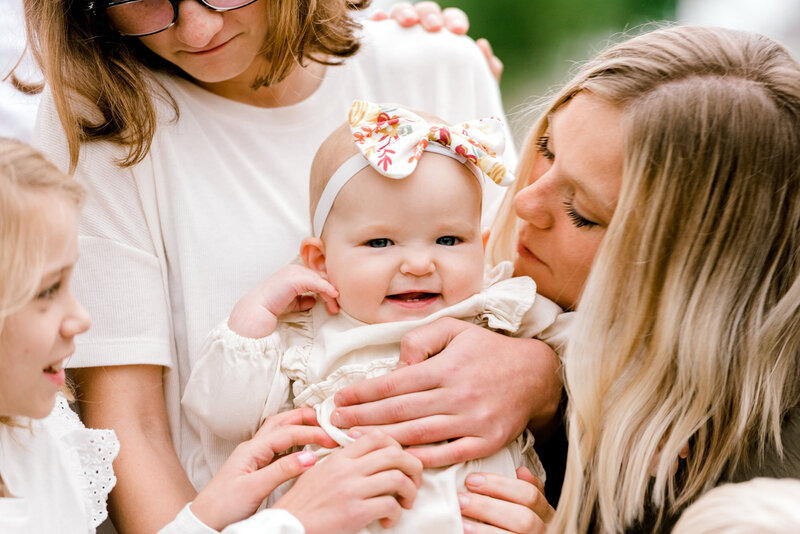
[0,138,83,424]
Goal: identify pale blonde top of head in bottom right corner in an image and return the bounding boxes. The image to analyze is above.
[672,478,800,534]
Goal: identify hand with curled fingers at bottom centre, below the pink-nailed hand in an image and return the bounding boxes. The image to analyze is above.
[273,431,422,534]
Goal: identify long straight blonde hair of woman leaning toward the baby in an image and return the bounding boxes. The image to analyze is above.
[490,27,800,532]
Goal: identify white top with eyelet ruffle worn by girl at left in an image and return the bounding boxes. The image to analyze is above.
[0,395,119,534]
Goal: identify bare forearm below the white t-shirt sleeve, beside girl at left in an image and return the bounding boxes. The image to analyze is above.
[72,365,196,534]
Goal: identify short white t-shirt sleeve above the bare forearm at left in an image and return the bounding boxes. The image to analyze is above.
[34,91,172,367]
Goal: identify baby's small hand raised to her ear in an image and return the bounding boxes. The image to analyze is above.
[228,265,339,338]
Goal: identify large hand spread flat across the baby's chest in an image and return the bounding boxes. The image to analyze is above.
[331,318,562,467]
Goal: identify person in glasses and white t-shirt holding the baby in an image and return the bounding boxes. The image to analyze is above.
[25,0,561,532]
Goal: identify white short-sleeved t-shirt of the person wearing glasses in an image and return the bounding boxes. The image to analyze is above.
[35,22,516,488]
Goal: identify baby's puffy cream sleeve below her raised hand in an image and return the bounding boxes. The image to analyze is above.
[181,320,289,441]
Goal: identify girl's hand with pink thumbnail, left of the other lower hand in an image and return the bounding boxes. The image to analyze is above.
[191,408,337,530]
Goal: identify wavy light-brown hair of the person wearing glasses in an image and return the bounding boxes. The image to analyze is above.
[24,0,369,169]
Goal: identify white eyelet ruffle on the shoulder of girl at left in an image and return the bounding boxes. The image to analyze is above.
[50,395,119,528]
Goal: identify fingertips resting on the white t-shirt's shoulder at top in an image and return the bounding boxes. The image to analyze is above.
[371,1,503,81]
